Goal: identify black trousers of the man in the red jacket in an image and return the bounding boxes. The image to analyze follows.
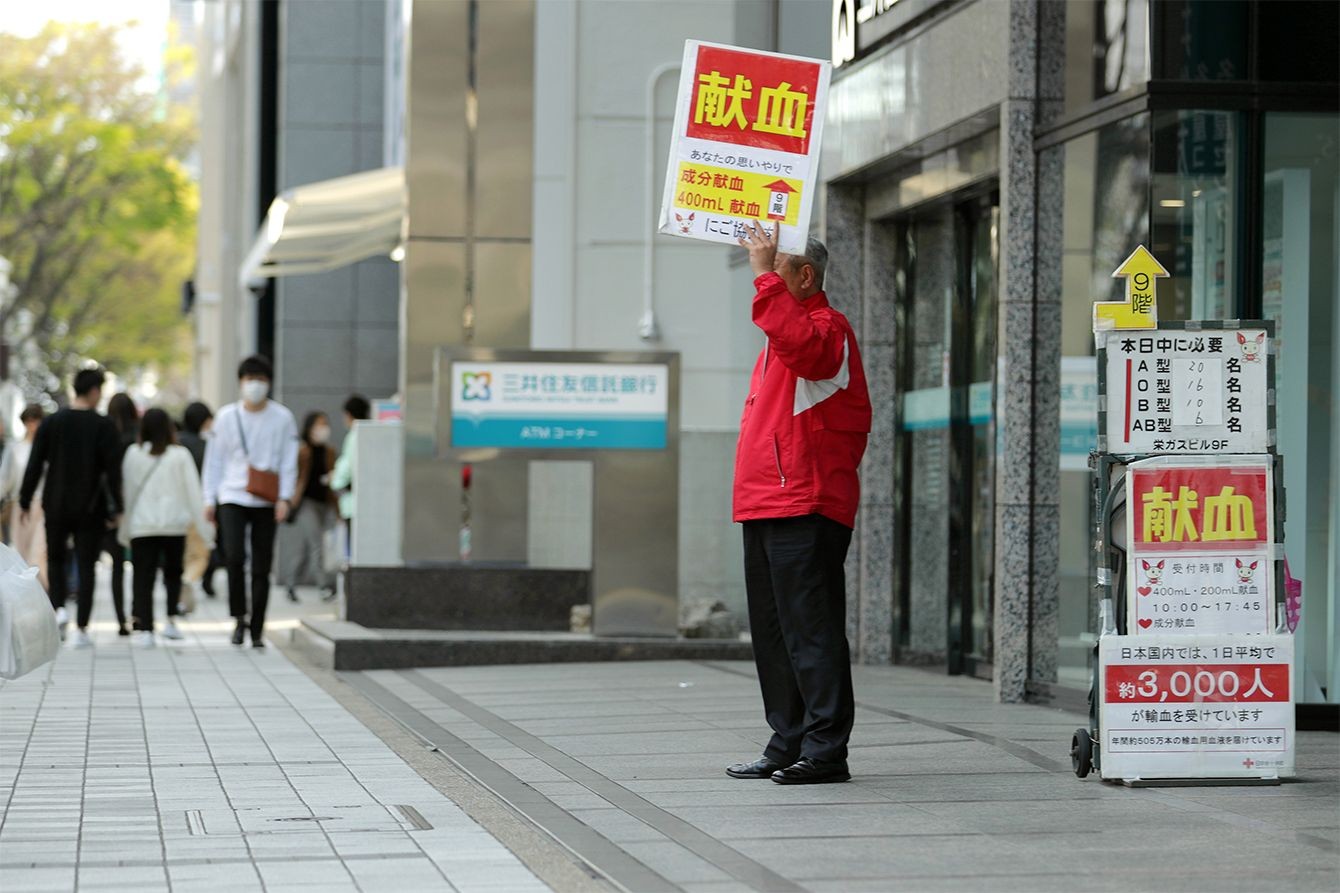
[744,515,856,766]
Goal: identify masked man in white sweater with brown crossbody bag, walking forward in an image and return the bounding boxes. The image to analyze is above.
[204,357,297,648]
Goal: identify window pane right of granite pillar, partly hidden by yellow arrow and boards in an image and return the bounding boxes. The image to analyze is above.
[1039,114,1150,687]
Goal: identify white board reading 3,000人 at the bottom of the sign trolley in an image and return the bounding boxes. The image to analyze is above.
[1099,636,1294,780]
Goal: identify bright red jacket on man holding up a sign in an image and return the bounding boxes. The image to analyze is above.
[734,272,870,527]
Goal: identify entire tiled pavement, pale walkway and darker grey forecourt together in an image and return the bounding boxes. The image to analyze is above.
[0,578,1340,893]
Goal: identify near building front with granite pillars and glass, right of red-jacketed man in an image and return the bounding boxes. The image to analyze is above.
[825,0,1340,704]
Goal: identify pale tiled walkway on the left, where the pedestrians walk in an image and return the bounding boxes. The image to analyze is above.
[0,575,548,893]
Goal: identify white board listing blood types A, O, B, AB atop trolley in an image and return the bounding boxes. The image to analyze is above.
[1103,329,1270,453]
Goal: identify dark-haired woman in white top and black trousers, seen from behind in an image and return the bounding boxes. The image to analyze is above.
[118,409,214,648]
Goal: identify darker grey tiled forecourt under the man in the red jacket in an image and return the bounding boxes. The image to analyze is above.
[343,662,1340,893]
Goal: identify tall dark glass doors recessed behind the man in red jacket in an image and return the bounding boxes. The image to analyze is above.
[894,193,1000,677]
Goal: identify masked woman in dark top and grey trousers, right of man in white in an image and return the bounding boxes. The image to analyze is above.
[279,412,336,602]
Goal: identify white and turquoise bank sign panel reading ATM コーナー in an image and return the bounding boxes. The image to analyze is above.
[450,361,670,449]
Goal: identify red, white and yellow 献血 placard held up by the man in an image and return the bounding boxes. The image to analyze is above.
[657,40,832,253]
